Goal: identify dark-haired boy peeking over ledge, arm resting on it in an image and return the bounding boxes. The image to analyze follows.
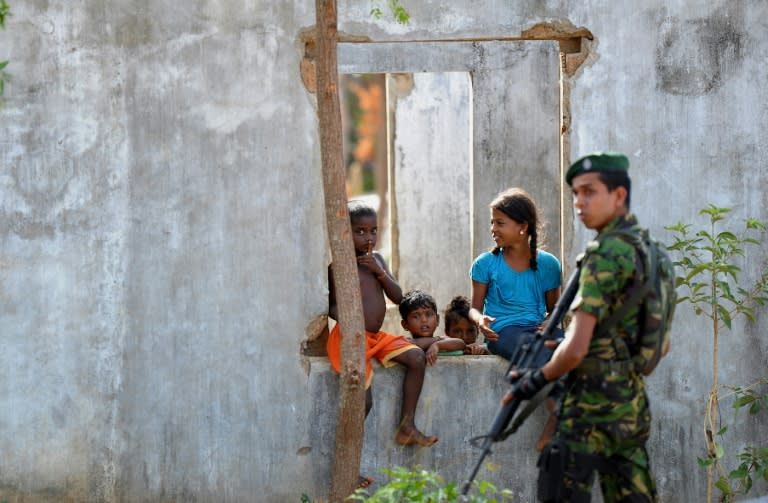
[400,290,466,365]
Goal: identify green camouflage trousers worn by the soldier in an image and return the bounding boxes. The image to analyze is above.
[544,374,658,503]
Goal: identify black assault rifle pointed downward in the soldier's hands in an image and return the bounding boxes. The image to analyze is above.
[461,267,580,495]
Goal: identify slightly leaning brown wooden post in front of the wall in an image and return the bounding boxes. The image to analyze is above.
[315,0,365,502]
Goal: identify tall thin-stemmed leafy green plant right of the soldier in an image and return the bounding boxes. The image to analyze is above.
[666,205,768,502]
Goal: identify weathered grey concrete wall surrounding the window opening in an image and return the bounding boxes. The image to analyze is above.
[0,0,768,502]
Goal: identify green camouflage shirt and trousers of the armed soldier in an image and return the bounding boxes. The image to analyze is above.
[557,215,658,503]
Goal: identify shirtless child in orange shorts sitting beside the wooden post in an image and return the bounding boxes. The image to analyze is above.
[327,201,438,456]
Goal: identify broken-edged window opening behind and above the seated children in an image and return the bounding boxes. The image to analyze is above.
[308,33,587,358]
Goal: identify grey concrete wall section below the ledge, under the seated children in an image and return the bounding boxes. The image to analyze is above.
[307,356,547,501]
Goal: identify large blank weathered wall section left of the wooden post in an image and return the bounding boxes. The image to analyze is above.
[0,0,328,501]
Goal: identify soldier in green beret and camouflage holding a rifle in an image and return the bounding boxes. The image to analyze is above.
[504,152,658,503]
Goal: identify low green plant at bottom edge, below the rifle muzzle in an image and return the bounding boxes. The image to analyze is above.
[348,466,513,503]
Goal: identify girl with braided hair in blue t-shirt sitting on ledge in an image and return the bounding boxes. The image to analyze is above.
[469,188,561,450]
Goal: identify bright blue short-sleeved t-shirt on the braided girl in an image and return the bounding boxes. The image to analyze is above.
[469,250,560,332]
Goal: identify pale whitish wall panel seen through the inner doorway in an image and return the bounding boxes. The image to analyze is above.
[392,72,472,308]
